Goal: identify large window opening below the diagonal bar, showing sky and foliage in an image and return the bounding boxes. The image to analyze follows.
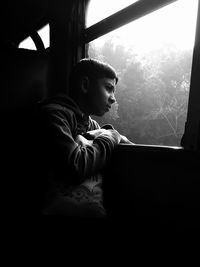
[89,0,198,146]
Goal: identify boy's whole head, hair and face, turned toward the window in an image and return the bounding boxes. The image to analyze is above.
[69,58,118,116]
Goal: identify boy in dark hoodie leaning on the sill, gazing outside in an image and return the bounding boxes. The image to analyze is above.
[39,59,131,217]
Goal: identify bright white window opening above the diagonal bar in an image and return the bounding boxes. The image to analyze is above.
[86,0,139,27]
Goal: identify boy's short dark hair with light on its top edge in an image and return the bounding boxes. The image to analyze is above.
[69,58,118,96]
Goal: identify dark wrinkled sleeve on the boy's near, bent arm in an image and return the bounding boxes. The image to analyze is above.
[38,105,120,184]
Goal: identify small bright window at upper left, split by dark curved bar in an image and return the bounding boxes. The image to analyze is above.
[19,24,49,50]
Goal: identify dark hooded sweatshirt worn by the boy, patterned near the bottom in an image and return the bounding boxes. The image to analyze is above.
[38,95,120,216]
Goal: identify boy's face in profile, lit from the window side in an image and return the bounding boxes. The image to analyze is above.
[87,77,116,116]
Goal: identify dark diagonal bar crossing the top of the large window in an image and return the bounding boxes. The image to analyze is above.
[81,0,177,43]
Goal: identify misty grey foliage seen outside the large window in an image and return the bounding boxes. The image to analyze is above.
[89,39,192,146]
